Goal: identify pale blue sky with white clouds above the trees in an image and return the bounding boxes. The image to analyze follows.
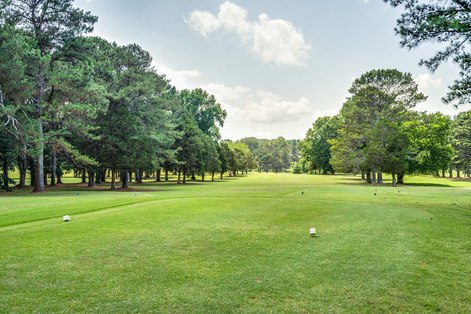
[76,0,471,139]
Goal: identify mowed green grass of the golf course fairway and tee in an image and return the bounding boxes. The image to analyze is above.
[0,174,471,313]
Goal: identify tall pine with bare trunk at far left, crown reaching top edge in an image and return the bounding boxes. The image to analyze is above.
[0,0,97,192]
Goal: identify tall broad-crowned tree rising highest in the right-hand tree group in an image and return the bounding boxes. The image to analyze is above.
[331,69,426,182]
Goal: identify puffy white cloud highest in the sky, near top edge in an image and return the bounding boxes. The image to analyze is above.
[186,1,311,65]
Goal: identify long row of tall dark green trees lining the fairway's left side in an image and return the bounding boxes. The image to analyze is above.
[0,0,253,192]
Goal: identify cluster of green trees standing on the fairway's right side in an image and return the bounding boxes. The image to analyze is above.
[301,69,471,185]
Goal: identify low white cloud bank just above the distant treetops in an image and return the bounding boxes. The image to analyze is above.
[154,64,318,139]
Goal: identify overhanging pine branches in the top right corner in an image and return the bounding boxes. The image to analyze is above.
[384,0,471,105]
